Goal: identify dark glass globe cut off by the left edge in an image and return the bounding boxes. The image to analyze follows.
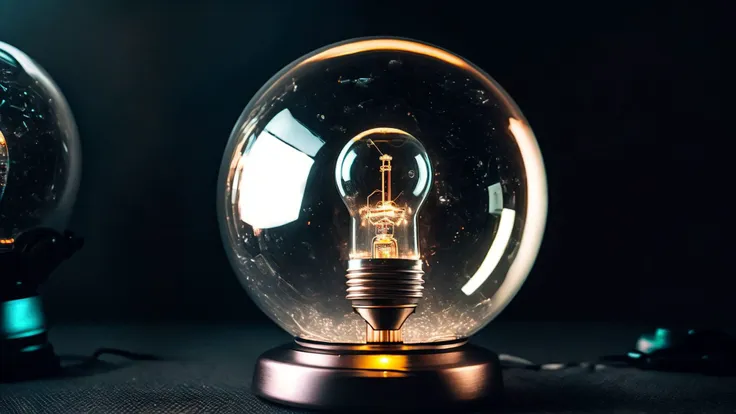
[0,42,80,243]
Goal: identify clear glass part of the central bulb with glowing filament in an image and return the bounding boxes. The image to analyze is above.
[335,128,432,260]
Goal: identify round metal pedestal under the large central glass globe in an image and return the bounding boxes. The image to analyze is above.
[253,340,503,411]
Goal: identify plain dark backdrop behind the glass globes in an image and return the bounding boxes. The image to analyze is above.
[0,0,736,325]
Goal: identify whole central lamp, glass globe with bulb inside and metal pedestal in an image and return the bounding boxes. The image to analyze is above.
[218,38,547,408]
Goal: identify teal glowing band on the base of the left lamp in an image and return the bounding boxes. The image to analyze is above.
[0,296,46,339]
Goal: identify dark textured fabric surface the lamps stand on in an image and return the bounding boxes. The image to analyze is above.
[0,324,736,414]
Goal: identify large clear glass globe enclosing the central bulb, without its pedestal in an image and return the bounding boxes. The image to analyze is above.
[218,38,547,343]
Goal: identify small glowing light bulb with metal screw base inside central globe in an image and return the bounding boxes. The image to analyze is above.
[335,127,432,343]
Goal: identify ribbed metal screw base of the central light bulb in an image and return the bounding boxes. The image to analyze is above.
[347,259,424,343]
